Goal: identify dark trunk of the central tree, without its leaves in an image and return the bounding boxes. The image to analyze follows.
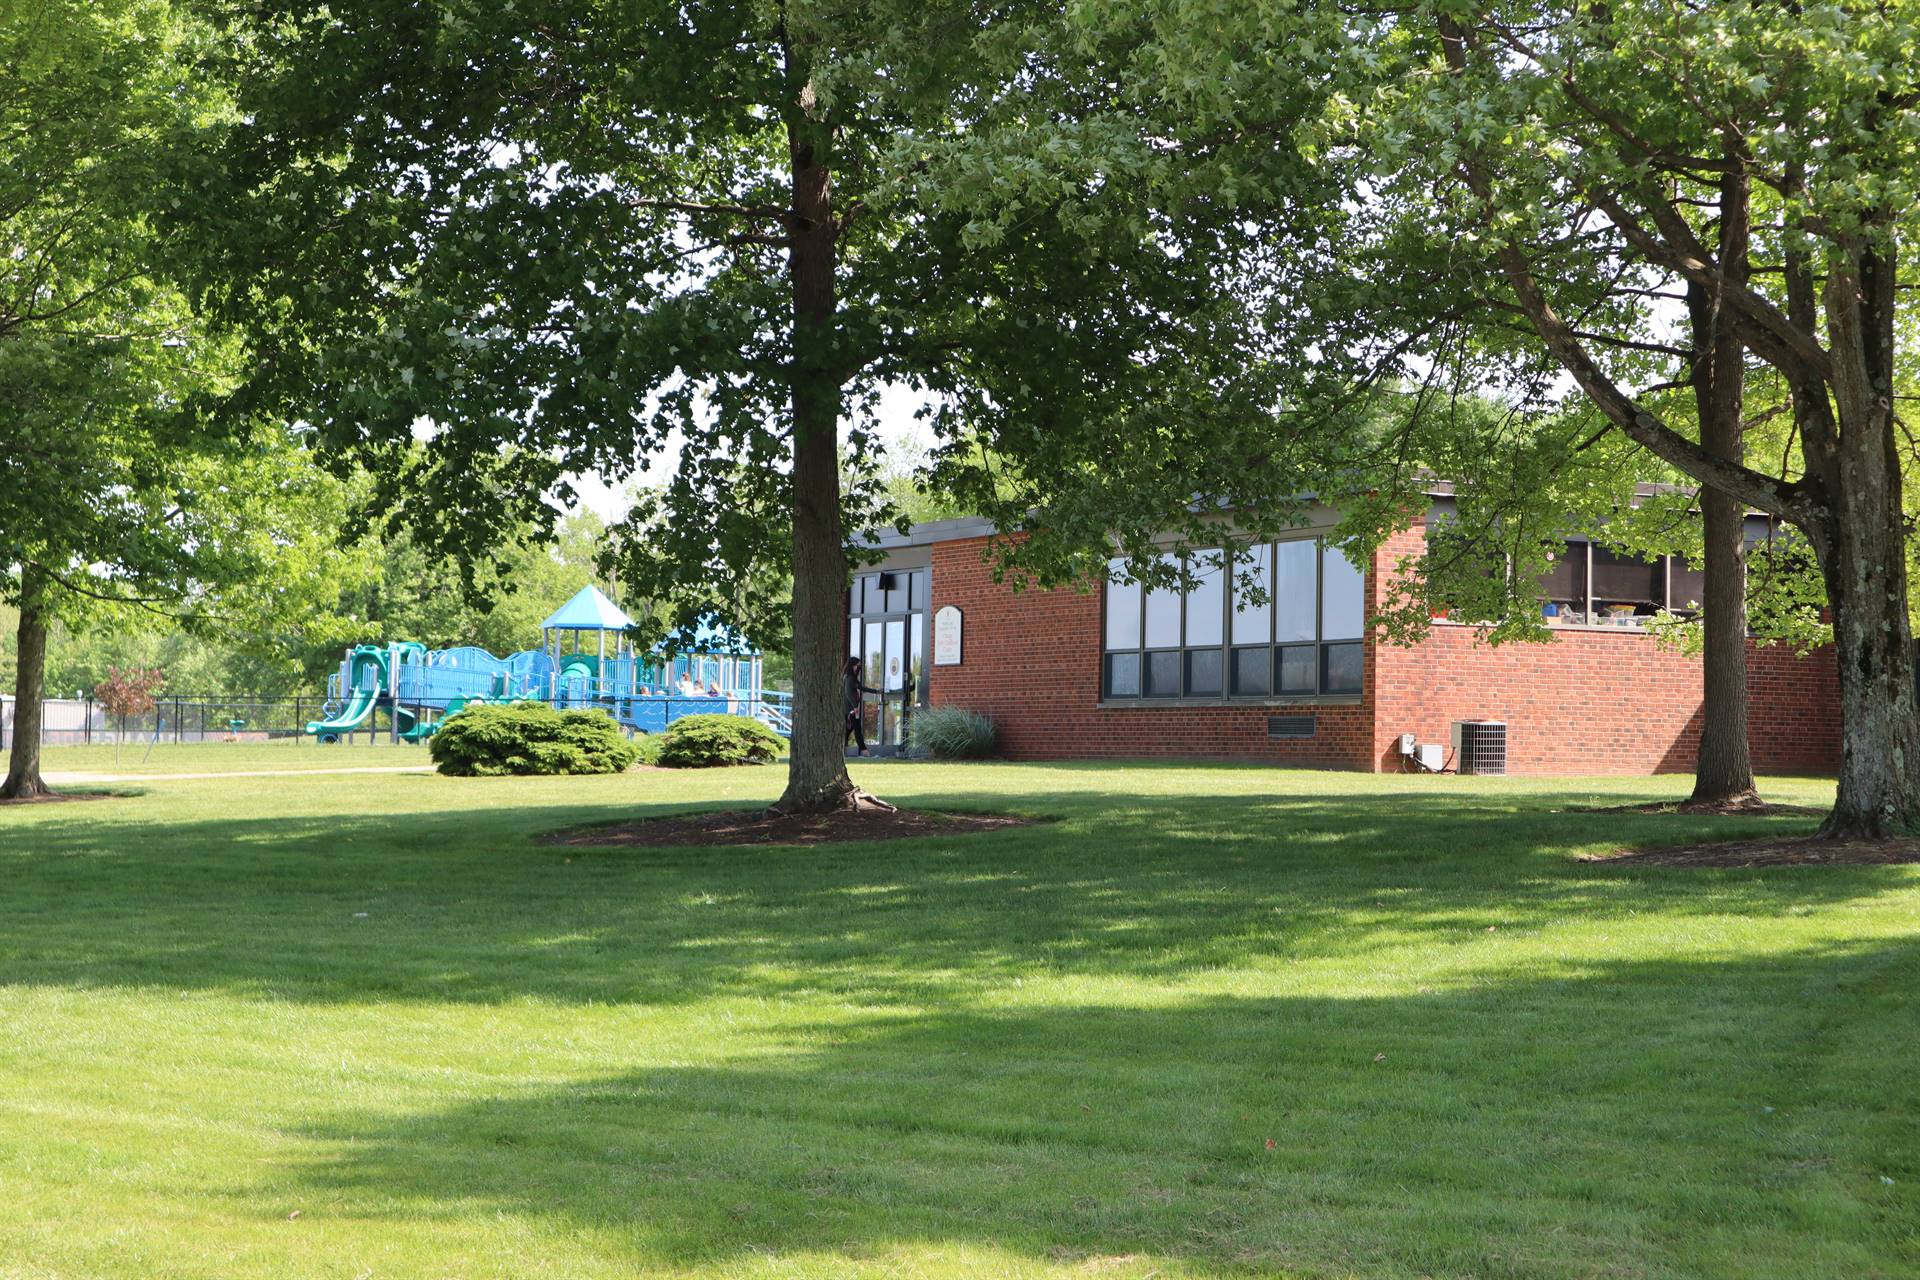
[774,58,860,814]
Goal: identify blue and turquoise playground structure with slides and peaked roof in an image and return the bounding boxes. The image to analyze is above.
[307,585,793,743]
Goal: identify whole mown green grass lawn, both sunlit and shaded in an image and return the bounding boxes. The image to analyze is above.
[0,767,1920,1280]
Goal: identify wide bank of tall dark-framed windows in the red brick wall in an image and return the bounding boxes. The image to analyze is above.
[1100,537,1367,700]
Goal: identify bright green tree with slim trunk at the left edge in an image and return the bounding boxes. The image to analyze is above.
[0,0,360,798]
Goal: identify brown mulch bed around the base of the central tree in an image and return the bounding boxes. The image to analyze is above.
[540,808,1037,848]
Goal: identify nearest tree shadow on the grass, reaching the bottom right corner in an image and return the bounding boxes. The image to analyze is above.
[274,940,1920,1278]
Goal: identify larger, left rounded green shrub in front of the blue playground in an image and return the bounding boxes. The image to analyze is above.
[428,702,639,777]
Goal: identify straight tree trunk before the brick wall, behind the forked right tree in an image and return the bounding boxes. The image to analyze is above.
[1688,160,1761,806]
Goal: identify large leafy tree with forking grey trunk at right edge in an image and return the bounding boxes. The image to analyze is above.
[1085,0,1920,837]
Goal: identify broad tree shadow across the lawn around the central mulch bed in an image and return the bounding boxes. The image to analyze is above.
[0,777,1889,1004]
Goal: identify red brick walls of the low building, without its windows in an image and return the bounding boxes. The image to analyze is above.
[929,530,1839,773]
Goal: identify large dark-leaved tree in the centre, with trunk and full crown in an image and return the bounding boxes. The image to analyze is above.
[177,0,1320,810]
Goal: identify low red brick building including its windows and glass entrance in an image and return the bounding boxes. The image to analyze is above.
[849,520,1839,773]
